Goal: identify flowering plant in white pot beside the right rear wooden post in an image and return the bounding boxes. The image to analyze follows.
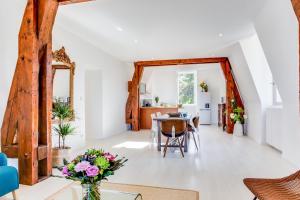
[230,99,247,136]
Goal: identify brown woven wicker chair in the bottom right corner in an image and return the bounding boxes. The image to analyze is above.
[244,171,300,200]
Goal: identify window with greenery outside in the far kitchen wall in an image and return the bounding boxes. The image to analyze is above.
[178,71,197,105]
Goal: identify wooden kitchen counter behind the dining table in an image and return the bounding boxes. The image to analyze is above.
[140,106,178,129]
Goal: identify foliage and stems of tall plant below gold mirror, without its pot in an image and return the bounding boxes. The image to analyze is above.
[52,101,75,149]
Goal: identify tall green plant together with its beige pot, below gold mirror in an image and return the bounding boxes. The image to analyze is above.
[52,101,75,167]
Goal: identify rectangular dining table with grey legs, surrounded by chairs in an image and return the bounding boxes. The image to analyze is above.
[153,115,191,152]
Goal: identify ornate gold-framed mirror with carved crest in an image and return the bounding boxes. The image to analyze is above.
[52,47,75,119]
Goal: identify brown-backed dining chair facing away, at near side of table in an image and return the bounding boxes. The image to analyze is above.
[161,119,187,157]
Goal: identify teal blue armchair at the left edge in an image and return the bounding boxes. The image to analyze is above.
[0,153,19,199]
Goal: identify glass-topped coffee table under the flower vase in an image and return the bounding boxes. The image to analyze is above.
[46,183,142,200]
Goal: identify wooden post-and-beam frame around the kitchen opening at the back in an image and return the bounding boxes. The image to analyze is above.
[126,57,244,133]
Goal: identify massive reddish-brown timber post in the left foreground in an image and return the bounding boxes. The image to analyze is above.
[1,0,92,185]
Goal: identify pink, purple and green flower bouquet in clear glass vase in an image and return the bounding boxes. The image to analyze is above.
[61,149,127,200]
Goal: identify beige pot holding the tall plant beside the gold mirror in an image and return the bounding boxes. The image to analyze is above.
[52,147,71,167]
